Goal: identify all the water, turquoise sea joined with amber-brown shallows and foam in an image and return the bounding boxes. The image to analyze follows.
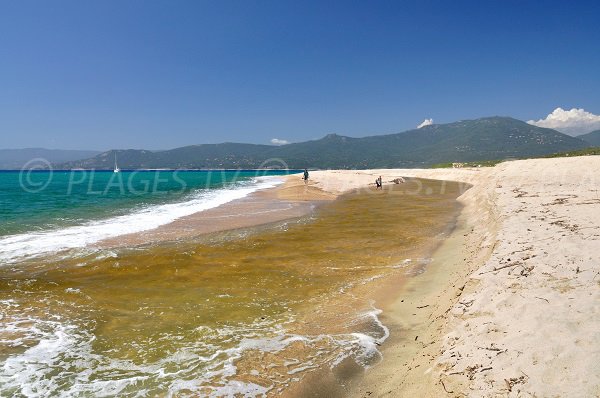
[0,170,462,397]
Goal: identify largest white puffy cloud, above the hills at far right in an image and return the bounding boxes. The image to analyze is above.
[527,108,600,135]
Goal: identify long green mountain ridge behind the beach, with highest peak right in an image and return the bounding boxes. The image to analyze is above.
[55,116,589,169]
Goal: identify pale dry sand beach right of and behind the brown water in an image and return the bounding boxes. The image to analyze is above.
[298,156,600,397]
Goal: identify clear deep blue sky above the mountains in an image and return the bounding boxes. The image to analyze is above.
[0,0,600,150]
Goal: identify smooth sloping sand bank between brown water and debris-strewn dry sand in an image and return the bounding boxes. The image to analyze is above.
[348,169,495,398]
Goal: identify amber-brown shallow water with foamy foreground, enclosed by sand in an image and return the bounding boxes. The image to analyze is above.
[0,180,461,396]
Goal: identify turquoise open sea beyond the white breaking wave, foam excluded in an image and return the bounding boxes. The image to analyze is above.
[0,171,287,236]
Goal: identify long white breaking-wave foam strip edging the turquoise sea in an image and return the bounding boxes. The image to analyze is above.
[0,177,282,264]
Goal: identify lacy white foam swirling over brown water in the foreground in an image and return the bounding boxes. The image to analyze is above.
[0,308,389,397]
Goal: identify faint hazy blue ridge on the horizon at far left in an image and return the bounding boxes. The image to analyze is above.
[0,148,100,170]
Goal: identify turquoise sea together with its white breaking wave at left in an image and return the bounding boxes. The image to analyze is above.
[0,170,290,261]
